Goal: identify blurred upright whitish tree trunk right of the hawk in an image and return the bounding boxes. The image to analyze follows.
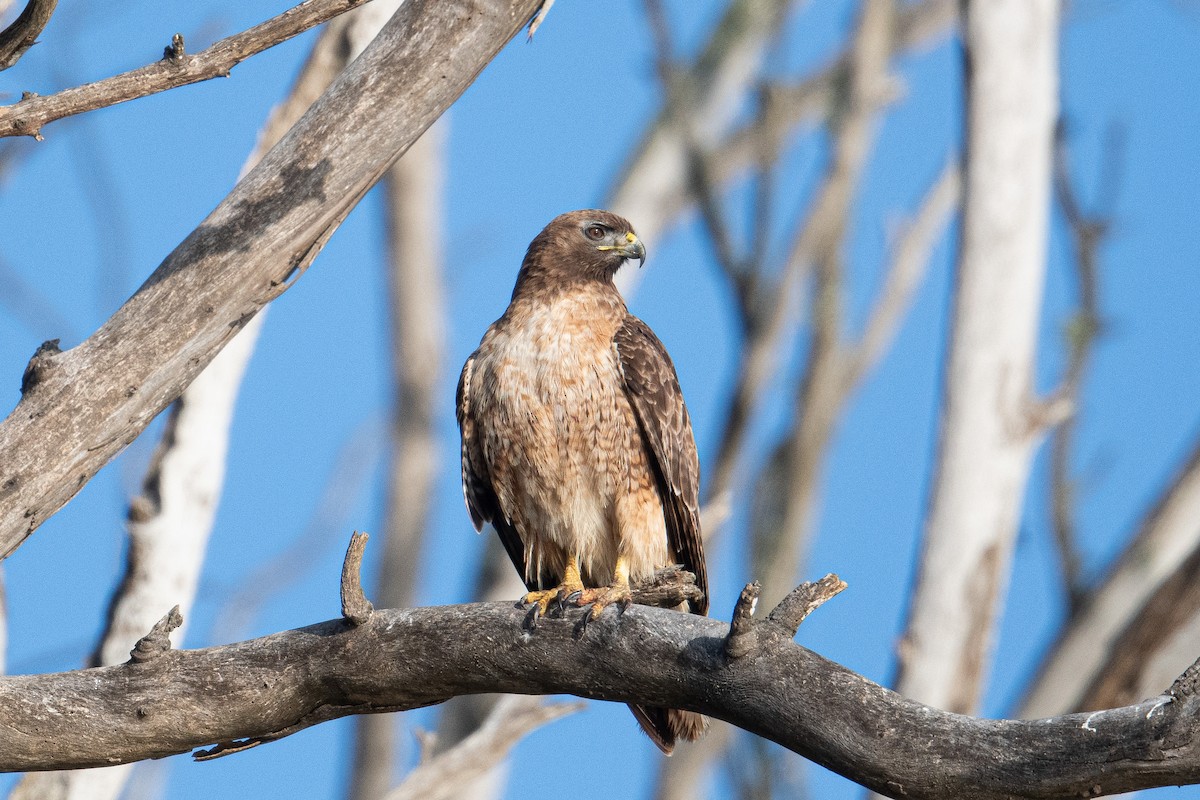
[896,0,1058,712]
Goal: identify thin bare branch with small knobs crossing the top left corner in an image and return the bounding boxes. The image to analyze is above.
[0,0,379,139]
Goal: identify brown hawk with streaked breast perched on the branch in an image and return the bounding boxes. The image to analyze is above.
[457,210,708,754]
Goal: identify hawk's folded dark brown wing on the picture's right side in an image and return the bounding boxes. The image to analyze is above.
[613,314,708,614]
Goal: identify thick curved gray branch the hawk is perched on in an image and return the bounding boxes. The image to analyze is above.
[0,603,1200,800]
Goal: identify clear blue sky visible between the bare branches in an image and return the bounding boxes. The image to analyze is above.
[0,0,1200,800]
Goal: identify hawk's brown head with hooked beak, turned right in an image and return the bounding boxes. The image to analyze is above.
[521,209,646,287]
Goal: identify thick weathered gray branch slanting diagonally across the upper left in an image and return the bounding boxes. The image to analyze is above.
[0,0,538,563]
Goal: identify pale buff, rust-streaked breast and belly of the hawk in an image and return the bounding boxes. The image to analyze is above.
[472,293,666,583]
